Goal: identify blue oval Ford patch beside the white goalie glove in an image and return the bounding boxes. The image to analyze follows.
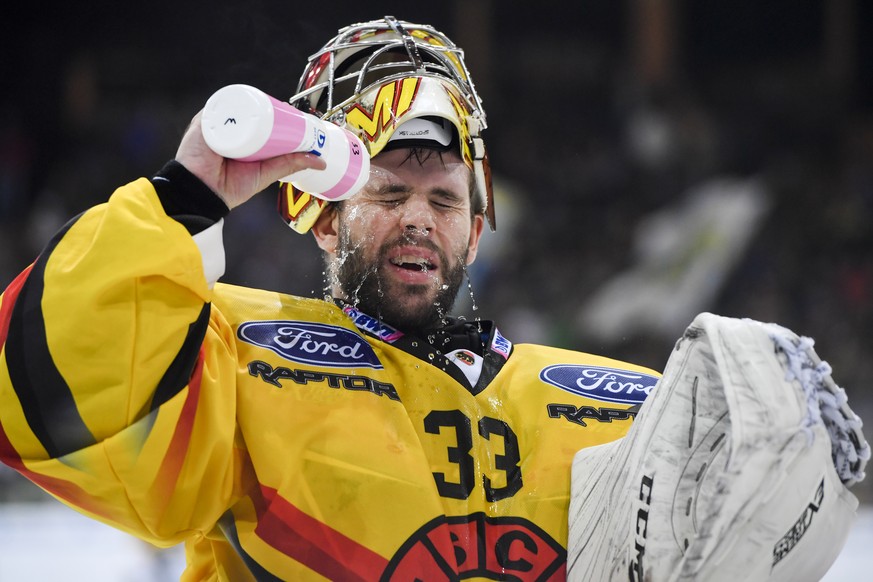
[540,364,658,404]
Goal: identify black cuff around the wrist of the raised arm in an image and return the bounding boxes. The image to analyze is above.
[152,160,230,235]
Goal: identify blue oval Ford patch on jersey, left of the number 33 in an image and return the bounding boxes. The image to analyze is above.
[237,321,382,368]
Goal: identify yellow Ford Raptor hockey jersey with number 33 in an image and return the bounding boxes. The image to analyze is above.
[0,179,657,581]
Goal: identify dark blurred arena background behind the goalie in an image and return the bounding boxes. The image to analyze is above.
[0,0,873,580]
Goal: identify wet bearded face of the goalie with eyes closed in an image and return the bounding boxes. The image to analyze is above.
[316,149,483,329]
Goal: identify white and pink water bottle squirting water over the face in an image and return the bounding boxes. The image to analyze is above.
[201,85,370,200]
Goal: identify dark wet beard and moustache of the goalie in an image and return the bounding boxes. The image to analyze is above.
[335,235,467,331]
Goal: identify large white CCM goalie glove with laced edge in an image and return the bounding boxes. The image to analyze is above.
[567,313,870,582]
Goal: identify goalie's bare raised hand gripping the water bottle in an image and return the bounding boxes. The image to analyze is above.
[176,112,325,209]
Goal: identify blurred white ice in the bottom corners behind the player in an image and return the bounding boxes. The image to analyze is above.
[0,502,873,582]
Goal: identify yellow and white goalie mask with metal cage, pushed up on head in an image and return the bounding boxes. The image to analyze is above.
[279,16,495,233]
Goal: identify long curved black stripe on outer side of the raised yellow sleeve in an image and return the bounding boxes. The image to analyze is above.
[6,214,96,458]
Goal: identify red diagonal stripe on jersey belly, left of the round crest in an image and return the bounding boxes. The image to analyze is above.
[255,485,388,581]
